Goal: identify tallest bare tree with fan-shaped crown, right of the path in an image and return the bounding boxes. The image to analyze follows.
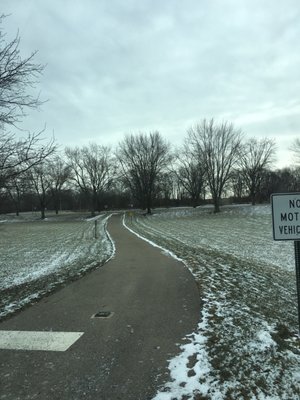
[188,119,241,213]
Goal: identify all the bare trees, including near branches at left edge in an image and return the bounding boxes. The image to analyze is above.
[0,16,300,218]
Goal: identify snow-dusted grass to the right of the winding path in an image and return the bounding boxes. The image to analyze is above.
[126,206,300,400]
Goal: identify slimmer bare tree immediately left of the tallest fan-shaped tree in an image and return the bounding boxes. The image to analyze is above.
[175,140,206,207]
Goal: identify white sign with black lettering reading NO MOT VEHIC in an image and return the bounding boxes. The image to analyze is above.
[271,193,300,240]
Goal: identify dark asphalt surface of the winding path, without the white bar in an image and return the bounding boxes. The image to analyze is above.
[0,215,200,400]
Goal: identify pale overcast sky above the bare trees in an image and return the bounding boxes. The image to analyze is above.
[0,0,300,167]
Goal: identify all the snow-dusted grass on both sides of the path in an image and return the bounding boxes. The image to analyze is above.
[0,206,300,400]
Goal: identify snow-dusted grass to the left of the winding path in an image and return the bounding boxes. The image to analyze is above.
[0,213,113,319]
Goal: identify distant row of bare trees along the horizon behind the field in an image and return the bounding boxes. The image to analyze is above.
[0,127,300,218]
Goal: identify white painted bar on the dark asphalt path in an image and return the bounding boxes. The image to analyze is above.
[0,331,84,351]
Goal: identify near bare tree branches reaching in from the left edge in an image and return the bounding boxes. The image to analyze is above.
[0,15,56,187]
